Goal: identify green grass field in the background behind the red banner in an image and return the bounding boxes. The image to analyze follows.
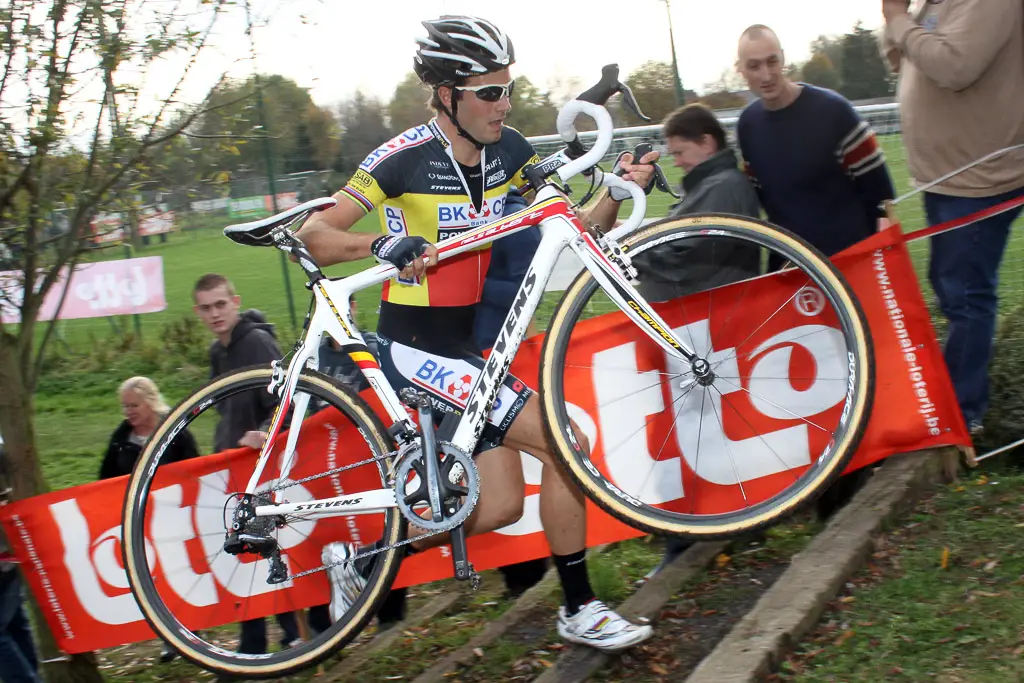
[28,131,1024,488]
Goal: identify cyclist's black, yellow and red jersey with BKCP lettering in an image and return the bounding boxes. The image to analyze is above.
[341,120,539,306]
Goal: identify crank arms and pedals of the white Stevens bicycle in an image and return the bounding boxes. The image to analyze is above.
[396,388,480,591]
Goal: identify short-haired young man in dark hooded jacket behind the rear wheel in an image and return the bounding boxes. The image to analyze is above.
[193,273,299,654]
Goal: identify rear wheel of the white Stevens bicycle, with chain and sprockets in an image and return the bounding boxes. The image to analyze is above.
[123,368,406,678]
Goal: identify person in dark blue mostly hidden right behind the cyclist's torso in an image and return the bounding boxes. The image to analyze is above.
[473,189,548,597]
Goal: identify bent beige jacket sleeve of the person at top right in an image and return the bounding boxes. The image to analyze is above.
[883,0,1021,91]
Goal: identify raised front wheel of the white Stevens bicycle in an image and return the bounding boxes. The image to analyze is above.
[540,215,874,540]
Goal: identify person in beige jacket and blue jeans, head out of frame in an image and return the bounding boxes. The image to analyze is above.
[882,0,1024,436]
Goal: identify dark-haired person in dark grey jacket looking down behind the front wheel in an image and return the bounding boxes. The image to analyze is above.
[633,104,761,579]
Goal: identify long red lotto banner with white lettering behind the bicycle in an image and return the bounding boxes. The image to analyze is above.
[0,227,970,652]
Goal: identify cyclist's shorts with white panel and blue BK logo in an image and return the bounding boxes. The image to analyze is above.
[377,332,534,453]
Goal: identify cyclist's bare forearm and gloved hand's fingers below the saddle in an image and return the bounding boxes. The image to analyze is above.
[296,193,437,278]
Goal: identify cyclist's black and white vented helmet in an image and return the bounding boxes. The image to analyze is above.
[413,15,515,87]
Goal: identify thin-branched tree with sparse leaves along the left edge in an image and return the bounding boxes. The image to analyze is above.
[0,0,227,682]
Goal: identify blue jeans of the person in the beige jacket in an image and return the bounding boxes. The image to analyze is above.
[925,187,1024,426]
